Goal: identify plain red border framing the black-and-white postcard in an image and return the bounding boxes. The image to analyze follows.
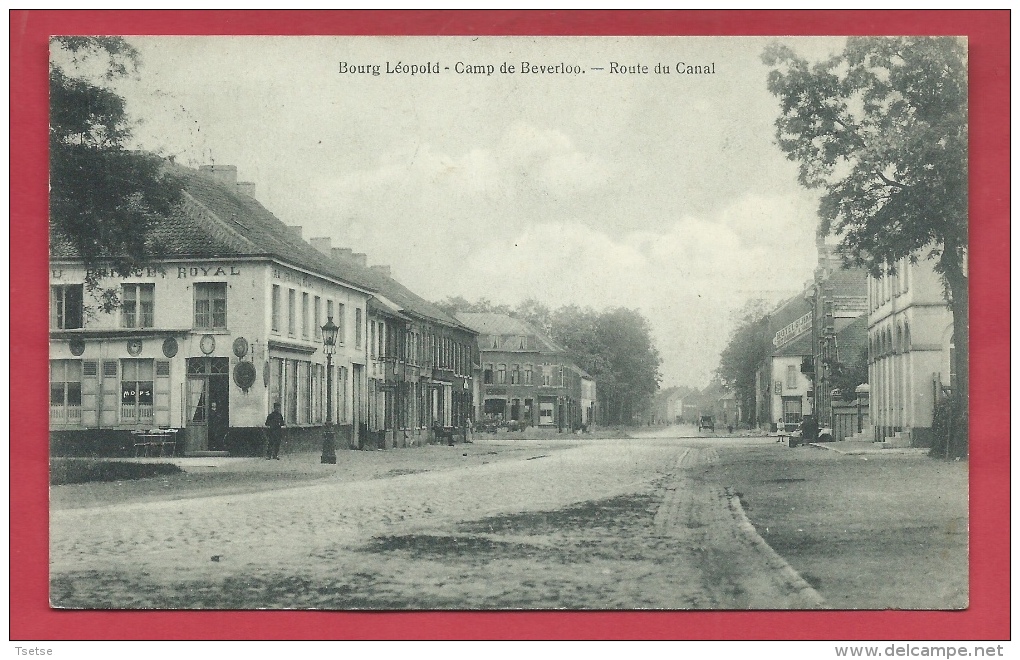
[9,10,1010,641]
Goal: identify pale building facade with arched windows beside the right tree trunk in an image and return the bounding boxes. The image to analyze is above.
[868,259,955,447]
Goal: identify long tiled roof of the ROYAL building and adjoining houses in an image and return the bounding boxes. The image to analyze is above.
[50,163,467,329]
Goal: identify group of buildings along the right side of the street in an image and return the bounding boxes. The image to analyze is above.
[752,234,954,447]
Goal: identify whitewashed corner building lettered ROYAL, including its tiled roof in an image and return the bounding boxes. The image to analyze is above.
[50,166,473,455]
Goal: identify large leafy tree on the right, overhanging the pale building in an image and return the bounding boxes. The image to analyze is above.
[762,37,970,451]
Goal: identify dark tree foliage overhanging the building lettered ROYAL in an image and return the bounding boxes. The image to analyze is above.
[49,37,181,311]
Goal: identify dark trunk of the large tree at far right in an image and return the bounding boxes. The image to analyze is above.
[941,245,970,456]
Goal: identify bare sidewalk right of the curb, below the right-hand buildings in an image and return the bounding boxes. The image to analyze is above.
[707,443,969,609]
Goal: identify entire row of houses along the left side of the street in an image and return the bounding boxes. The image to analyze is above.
[50,165,596,455]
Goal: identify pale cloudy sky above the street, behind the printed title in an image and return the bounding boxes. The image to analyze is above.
[109,37,843,388]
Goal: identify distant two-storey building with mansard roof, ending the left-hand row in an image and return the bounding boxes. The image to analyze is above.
[457,312,598,430]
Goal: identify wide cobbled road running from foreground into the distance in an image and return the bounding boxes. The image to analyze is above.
[50,438,823,609]
